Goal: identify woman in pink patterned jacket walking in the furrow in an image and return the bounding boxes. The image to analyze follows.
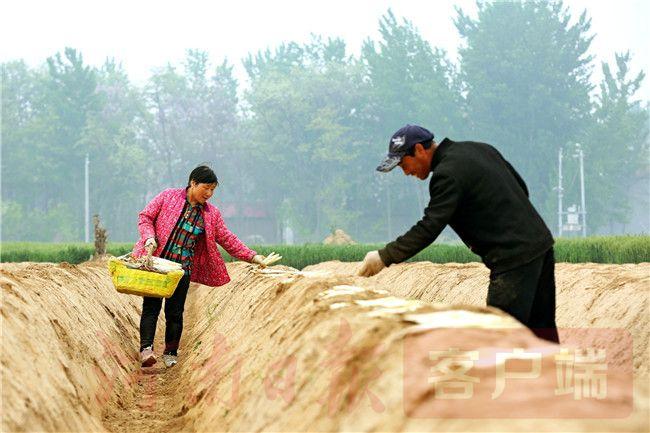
[133,165,266,367]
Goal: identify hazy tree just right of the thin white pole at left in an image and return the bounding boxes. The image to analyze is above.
[80,59,153,241]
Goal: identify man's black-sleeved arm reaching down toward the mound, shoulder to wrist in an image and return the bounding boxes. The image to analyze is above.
[379,174,462,266]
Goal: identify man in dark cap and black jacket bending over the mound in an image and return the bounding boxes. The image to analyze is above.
[359,125,559,342]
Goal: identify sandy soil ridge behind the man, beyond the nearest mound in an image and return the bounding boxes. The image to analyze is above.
[305,261,650,376]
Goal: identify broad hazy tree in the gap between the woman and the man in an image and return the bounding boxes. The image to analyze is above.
[244,37,363,241]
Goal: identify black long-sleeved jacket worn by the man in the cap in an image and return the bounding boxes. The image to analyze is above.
[379,138,553,272]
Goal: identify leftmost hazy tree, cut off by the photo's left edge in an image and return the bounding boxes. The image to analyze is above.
[0,61,78,241]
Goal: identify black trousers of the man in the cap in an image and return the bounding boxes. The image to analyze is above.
[487,248,560,343]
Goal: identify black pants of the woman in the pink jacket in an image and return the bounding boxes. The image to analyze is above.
[140,274,190,355]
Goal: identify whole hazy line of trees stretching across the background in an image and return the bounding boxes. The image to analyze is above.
[0,2,649,242]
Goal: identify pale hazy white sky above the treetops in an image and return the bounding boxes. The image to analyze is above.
[0,0,650,100]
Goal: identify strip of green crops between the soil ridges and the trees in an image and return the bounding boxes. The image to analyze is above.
[0,236,650,269]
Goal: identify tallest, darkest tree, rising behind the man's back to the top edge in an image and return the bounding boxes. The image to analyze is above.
[455,1,592,227]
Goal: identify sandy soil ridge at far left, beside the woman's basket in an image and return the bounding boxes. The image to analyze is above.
[0,263,138,431]
